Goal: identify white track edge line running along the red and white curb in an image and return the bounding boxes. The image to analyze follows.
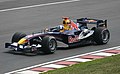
[5,46,120,74]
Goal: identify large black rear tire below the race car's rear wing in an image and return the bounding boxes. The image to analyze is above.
[93,27,110,45]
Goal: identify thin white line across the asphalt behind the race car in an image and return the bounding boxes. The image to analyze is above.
[0,0,80,12]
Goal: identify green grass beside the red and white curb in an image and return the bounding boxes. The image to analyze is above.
[43,55,120,74]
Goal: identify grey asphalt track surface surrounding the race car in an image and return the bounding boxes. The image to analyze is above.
[0,0,120,74]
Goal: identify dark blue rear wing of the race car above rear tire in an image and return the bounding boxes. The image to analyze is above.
[77,18,107,28]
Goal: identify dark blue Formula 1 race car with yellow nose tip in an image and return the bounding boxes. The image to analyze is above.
[5,18,110,54]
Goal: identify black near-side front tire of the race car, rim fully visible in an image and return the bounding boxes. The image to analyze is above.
[42,36,57,54]
